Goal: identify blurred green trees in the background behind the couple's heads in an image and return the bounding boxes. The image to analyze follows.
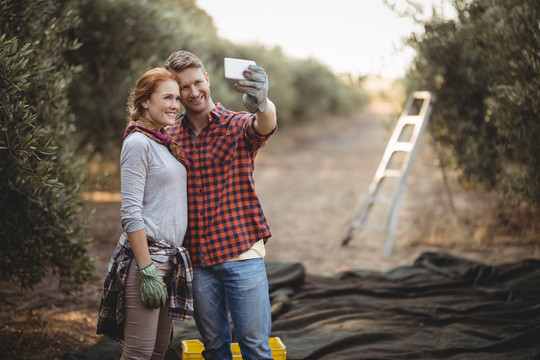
[68,0,366,153]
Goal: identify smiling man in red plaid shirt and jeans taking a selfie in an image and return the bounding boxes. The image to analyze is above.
[165,51,277,360]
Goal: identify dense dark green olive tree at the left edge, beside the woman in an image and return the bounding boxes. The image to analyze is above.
[0,0,93,291]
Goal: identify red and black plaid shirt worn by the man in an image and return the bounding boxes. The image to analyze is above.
[168,104,274,267]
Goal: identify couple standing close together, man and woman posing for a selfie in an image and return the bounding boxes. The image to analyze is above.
[98,51,277,360]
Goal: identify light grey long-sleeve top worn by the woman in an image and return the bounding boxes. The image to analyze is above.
[120,132,188,247]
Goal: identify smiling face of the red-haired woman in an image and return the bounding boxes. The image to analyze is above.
[142,80,180,126]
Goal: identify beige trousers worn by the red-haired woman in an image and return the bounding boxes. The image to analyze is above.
[121,259,172,360]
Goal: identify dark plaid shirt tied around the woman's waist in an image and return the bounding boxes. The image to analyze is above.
[96,233,193,342]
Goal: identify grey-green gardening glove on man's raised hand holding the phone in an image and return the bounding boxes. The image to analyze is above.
[234,65,268,114]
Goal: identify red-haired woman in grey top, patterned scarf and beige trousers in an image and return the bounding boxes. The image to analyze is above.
[97,68,193,359]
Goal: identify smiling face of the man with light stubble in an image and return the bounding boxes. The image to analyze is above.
[174,68,214,113]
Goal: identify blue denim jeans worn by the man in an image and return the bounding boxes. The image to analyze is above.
[193,259,272,360]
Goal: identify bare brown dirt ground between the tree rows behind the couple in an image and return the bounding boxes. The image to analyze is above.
[0,91,540,359]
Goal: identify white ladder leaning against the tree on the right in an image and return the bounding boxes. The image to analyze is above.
[341,91,435,255]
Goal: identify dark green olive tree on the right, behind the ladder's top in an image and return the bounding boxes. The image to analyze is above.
[407,0,540,207]
